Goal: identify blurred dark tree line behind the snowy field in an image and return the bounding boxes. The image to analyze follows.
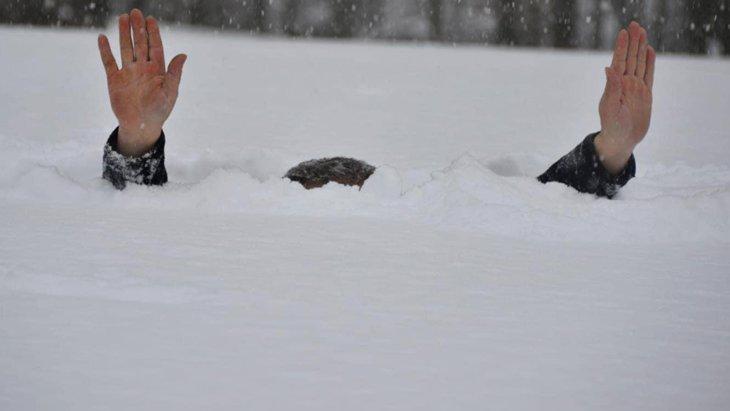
[0,0,730,55]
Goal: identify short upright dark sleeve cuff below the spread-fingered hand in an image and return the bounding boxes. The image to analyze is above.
[102,128,167,190]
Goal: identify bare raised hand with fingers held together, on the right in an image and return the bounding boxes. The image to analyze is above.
[594,22,656,174]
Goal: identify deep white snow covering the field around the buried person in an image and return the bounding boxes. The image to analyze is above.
[0,28,730,410]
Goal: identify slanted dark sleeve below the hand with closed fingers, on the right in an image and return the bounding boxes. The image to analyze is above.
[537,133,636,198]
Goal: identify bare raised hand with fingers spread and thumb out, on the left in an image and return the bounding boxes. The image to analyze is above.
[99,9,187,156]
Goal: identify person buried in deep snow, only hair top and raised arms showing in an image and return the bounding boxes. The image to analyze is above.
[98,9,656,198]
